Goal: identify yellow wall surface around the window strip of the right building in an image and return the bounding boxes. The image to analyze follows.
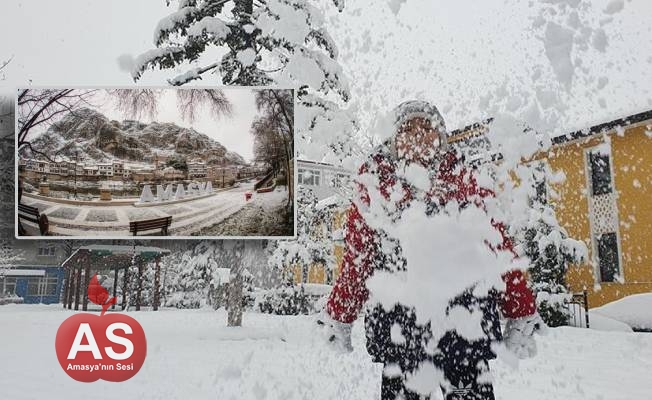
[546,124,652,307]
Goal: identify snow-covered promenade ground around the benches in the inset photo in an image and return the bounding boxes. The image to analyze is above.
[18,181,293,238]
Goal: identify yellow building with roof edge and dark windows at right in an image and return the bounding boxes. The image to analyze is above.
[450,110,652,307]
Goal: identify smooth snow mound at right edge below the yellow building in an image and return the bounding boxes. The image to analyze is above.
[591,293,652,330]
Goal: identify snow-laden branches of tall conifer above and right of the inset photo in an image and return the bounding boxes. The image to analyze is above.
[130,0,355,162]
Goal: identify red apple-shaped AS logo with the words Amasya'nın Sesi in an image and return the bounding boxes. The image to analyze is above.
[55,275,147,382]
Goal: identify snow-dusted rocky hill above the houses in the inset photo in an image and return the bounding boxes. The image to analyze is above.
[25,108,246,164]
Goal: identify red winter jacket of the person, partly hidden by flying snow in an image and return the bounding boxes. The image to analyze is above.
[326,153,536,323]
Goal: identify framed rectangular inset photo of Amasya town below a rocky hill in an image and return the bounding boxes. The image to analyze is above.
[16,88,295,238]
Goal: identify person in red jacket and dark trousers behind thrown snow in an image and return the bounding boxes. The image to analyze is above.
[318,101,544,400]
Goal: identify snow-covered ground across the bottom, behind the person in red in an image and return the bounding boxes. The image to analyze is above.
[0,305,652,400]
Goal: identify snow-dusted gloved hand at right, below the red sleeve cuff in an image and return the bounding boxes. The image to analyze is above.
[503,313,548,359]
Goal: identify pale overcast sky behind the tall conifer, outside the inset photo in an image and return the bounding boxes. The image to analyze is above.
[0,0,652,157]
